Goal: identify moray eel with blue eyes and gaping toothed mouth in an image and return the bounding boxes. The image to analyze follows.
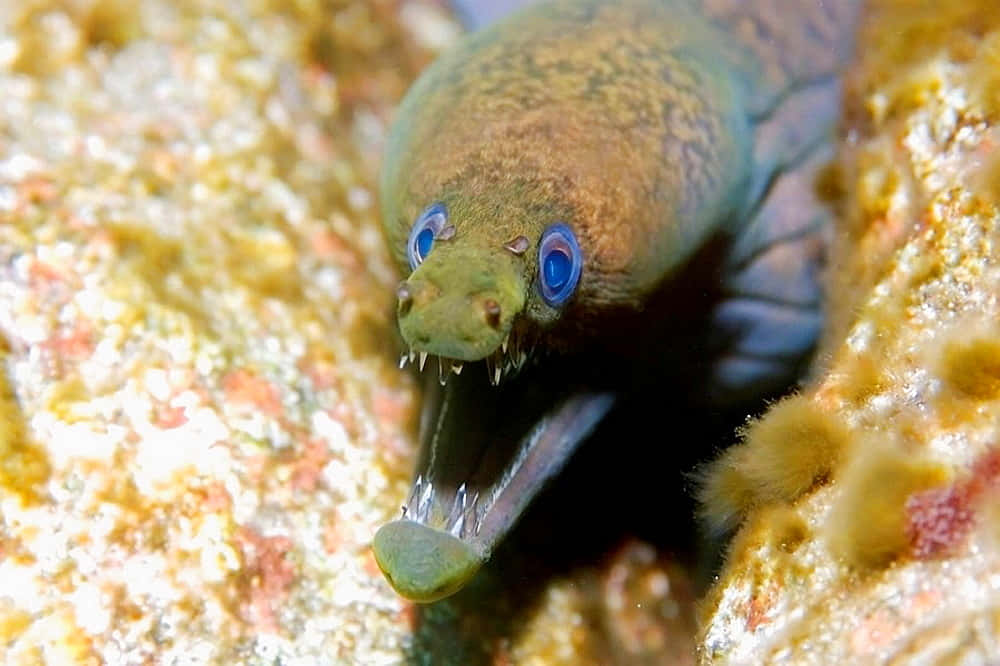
[373,0,859,602]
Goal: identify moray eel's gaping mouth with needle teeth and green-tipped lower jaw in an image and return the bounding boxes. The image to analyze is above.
[374,346,614,601]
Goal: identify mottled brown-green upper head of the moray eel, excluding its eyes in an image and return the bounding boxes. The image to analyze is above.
[383,2,750,360]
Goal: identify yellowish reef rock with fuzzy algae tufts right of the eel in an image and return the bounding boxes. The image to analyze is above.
[699,0,1000,664]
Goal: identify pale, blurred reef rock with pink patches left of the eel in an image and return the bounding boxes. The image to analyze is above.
[0,0,446,664]
